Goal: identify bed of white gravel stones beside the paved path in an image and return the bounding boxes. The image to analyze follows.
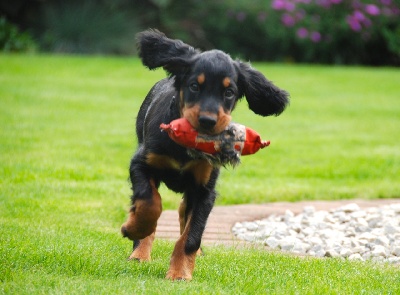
[232,203,400,264]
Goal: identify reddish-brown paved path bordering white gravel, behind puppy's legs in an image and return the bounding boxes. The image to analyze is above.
[156,199,400,246]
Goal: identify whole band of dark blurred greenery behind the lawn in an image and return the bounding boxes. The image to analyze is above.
[0,0,400,66]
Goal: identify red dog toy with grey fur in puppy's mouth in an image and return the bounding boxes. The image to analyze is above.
[160,118,270,165]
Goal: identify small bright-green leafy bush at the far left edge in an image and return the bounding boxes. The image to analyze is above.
[0,17,36,52]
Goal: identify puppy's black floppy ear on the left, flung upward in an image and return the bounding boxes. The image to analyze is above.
[137,30,197,74]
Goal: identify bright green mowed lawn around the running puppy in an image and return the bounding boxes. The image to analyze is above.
[0,55,400,294]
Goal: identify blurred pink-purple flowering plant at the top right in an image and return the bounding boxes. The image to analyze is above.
[272,0,400,43]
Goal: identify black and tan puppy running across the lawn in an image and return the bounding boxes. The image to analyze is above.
[121,30,289,280]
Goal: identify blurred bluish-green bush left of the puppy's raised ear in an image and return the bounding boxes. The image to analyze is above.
[41,0,137,54]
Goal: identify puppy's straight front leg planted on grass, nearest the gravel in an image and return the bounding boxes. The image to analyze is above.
[167,183,216,281]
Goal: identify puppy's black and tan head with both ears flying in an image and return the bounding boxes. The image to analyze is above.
[138,30,289,134]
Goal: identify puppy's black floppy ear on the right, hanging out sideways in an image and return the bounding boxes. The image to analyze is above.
[236,61,289,116]
